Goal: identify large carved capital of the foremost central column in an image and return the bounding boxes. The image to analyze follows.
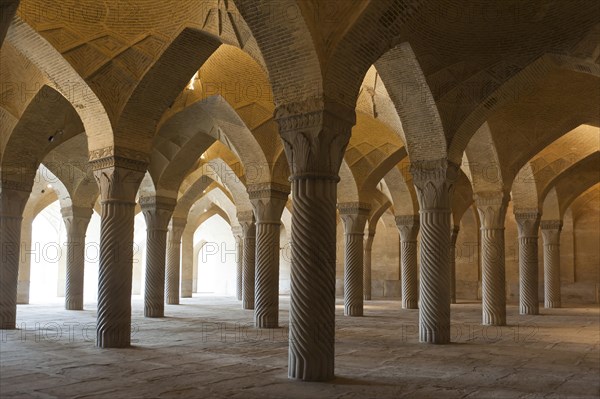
[275,98,356,181]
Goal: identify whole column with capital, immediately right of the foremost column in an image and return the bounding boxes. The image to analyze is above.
[338,203,369,316]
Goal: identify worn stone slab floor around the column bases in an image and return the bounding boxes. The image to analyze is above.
[0,295,600,399]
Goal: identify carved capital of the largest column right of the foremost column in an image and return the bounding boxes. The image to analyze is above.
[410,158,459,211]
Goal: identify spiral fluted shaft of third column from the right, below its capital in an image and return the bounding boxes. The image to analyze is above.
[481,228,506,326]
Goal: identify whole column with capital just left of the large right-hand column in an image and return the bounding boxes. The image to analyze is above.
[396,215,419,309]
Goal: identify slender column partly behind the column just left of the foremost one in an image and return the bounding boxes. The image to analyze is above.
[238,211,256,309]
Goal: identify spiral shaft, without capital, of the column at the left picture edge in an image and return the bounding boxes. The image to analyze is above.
[0,216,22,330]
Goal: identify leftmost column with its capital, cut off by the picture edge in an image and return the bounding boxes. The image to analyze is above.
[0,186,31,330]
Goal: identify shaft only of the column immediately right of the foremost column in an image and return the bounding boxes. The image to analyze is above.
[344,233,363,316]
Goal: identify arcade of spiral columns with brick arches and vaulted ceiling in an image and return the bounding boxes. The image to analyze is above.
[0,0,600,381]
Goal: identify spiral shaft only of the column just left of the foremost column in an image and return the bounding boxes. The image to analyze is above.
[254,222,281,328]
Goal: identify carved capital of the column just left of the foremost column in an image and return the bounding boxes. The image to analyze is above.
[248,183,290,224]
